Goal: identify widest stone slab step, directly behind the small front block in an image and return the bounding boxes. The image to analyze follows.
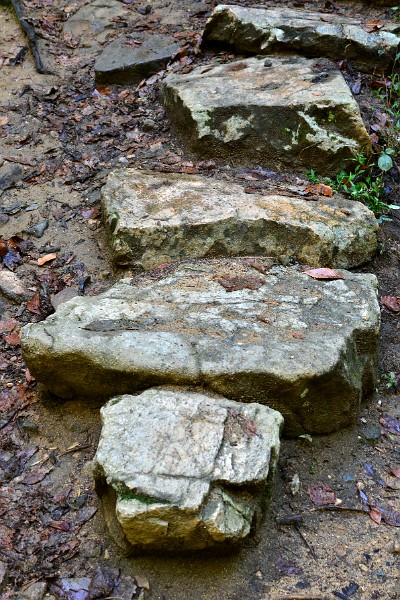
[22,259,380,435]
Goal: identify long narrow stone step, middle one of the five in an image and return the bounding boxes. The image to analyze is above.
[102,169,377,270]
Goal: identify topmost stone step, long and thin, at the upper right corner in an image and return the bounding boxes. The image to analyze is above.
[203,4,400,72]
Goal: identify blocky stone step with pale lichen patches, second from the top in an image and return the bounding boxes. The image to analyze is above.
[163,56,371,174]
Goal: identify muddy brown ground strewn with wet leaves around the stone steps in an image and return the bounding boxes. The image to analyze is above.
[0,0,400,600]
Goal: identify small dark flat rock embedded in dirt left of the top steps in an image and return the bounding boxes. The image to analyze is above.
[94,33,180,85]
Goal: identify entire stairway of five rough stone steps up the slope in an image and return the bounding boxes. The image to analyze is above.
[22,1,388,552]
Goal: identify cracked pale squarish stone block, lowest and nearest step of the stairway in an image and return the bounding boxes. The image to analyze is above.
[94,388,283,552]
